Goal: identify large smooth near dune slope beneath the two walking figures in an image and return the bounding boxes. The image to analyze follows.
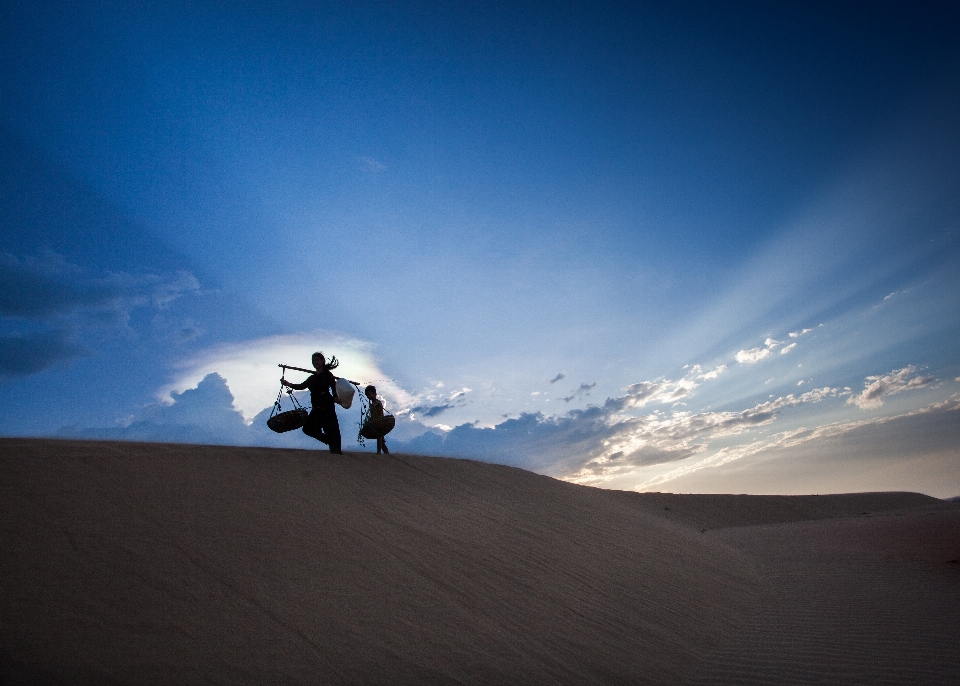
[0,439,755,684]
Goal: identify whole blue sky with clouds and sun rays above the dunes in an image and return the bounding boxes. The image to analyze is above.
[0,0,960,497]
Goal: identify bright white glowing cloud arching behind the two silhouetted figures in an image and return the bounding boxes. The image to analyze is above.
[167,331,413,422]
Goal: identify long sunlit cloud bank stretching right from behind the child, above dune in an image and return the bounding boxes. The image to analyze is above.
[394,362,933,488]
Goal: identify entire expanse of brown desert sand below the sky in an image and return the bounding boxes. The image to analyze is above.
[0,439,960,684]
